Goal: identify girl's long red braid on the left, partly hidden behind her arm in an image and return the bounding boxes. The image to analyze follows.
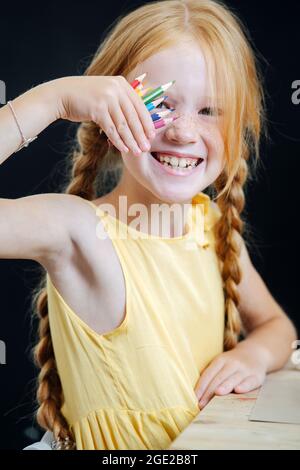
[33,123,112,450]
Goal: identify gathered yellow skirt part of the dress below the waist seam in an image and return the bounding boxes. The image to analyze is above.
[70,405,199,450]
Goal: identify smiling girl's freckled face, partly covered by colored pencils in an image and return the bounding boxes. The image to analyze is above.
[122,42,224,202]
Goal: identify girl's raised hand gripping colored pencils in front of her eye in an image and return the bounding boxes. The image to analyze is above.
[56,75,155,155]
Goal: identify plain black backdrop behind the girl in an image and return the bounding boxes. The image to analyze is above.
[0,0,300,449]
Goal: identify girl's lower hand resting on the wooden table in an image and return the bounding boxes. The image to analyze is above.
[195,343,267,409]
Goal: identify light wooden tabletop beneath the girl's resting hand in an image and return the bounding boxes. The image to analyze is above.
[168,370,300,450]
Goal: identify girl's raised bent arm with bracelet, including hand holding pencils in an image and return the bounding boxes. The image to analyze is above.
[0,76,154,263]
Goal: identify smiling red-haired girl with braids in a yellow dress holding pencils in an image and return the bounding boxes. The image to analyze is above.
[0,0,296,449]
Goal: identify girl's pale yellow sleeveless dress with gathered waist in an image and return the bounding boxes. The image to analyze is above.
[47,193,224,450]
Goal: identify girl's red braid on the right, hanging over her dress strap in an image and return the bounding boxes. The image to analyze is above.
[214,158,248,350]
